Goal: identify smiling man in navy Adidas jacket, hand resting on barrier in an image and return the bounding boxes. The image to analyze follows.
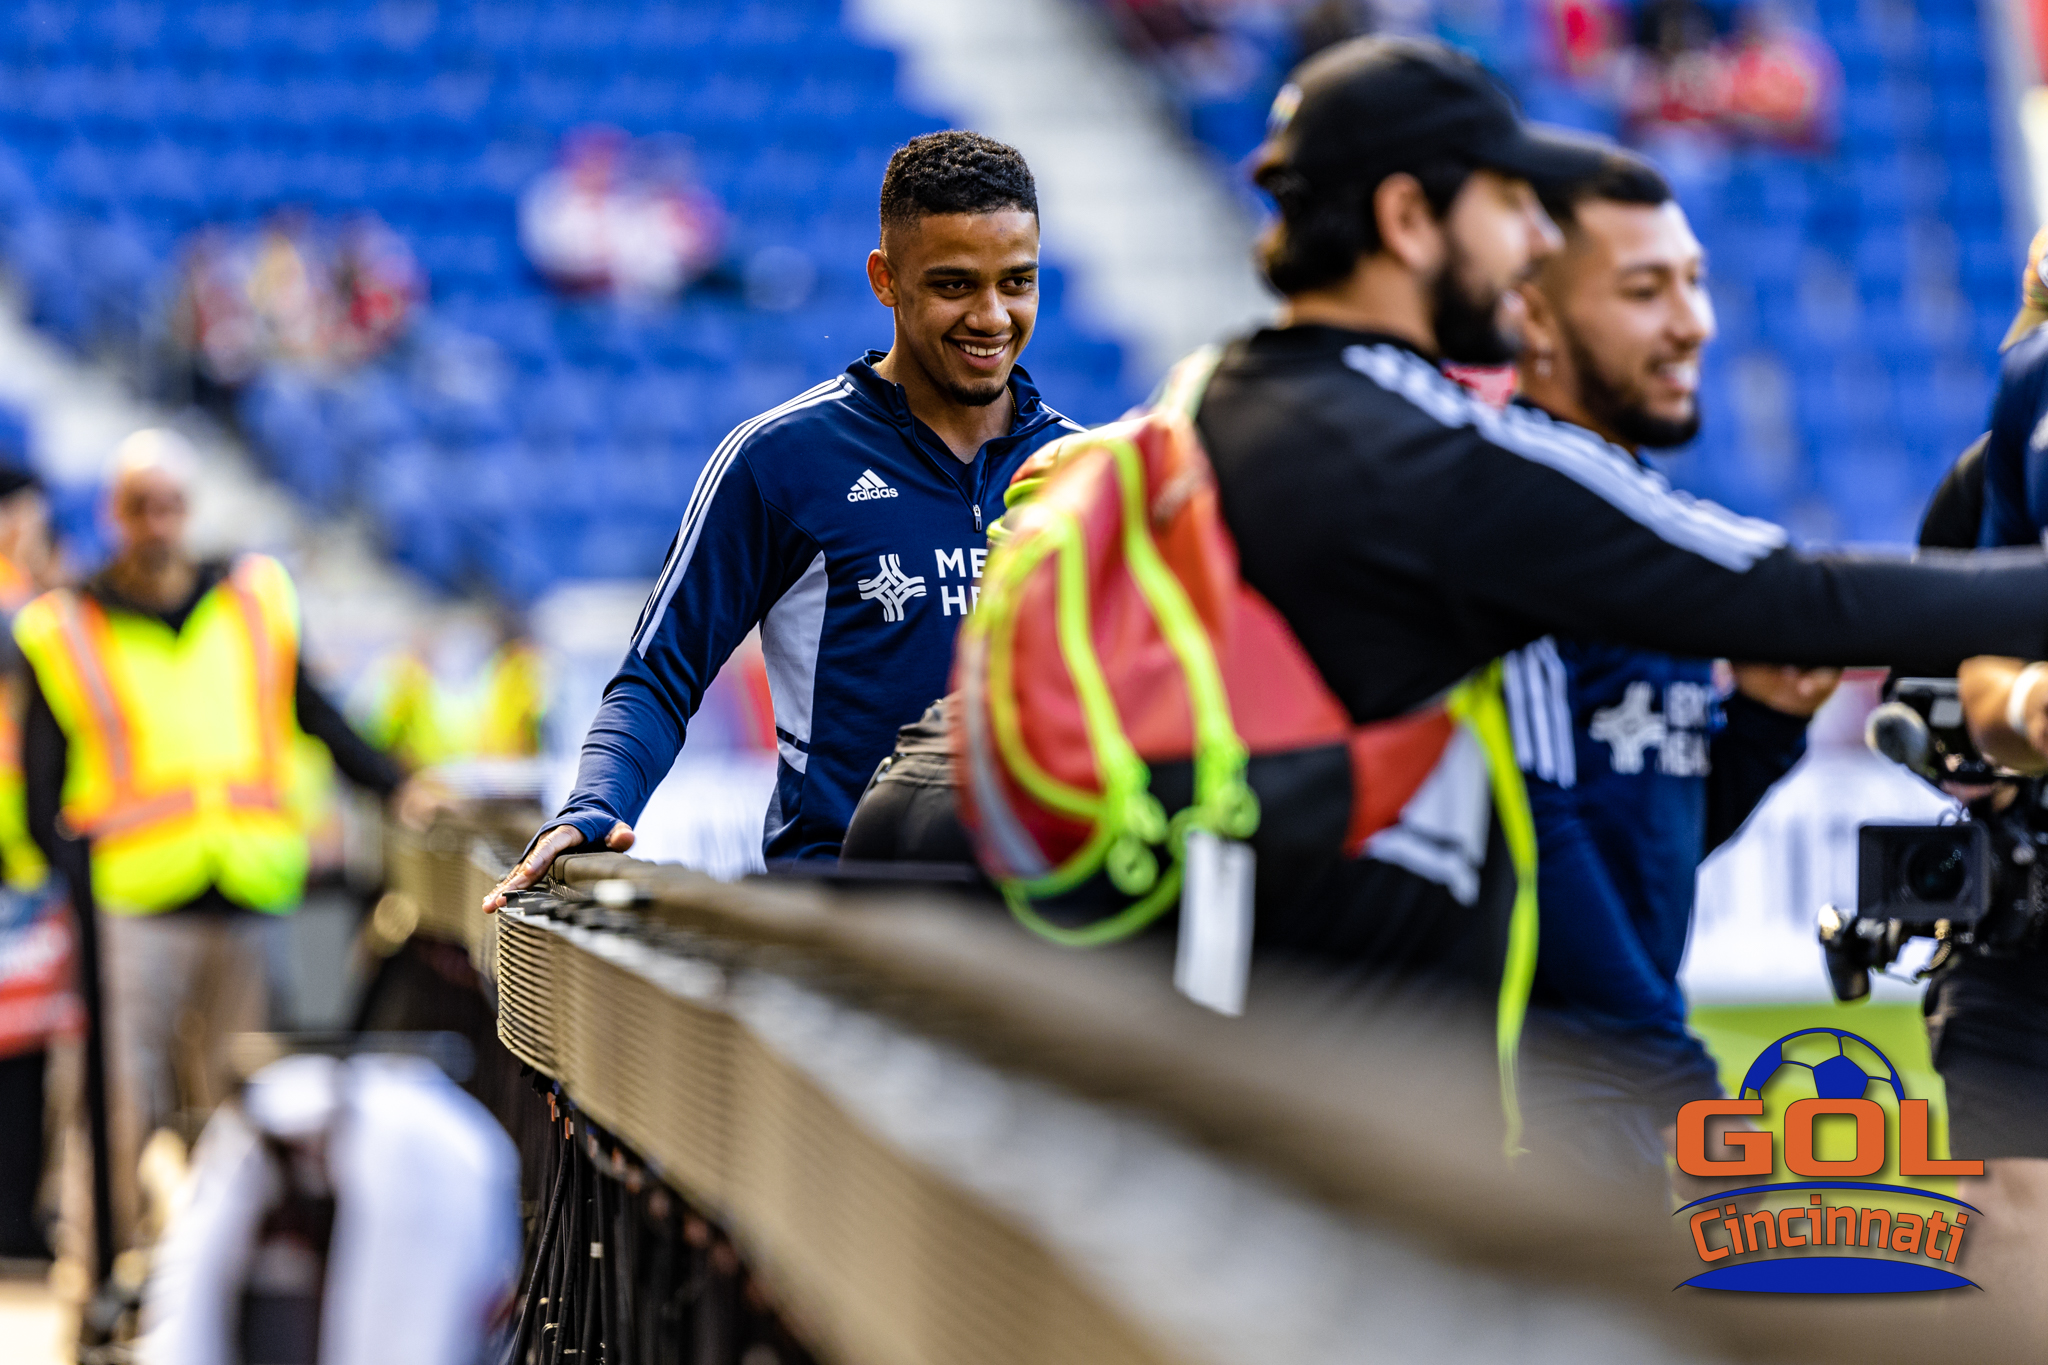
[487,131,1079,909]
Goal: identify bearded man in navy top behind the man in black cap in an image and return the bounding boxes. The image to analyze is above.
[1507,149,1839,1199]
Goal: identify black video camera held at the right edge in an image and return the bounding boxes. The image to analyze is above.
[1821,677,2048,1001]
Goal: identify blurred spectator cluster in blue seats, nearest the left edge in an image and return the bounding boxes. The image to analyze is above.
[172,215,426,389]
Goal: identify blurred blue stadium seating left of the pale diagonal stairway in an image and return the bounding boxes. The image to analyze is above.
[0,0,1137,604]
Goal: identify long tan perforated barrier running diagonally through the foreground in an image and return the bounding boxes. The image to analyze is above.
[391,810,2042,1365]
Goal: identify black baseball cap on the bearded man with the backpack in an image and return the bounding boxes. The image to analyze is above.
[1257,37,1606,194]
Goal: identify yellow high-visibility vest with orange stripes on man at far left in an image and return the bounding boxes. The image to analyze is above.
[14,555,307,915]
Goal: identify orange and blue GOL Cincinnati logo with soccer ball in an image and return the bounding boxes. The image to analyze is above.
[1675,1029,1985,1293]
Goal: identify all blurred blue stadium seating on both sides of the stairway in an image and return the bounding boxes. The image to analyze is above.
[0,0,2017,602]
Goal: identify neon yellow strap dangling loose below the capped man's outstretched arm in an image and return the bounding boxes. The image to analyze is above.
[1446,659,1538,1160]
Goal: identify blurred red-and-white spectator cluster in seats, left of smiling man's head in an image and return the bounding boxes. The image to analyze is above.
[518,127,725,299]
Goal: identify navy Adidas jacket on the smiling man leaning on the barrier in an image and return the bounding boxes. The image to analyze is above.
[557,352,1081,857]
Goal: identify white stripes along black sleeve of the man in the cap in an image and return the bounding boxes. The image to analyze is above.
[1343,344,1786,573]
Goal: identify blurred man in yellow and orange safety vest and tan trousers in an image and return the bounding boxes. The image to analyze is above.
[14,430,401,1268]
